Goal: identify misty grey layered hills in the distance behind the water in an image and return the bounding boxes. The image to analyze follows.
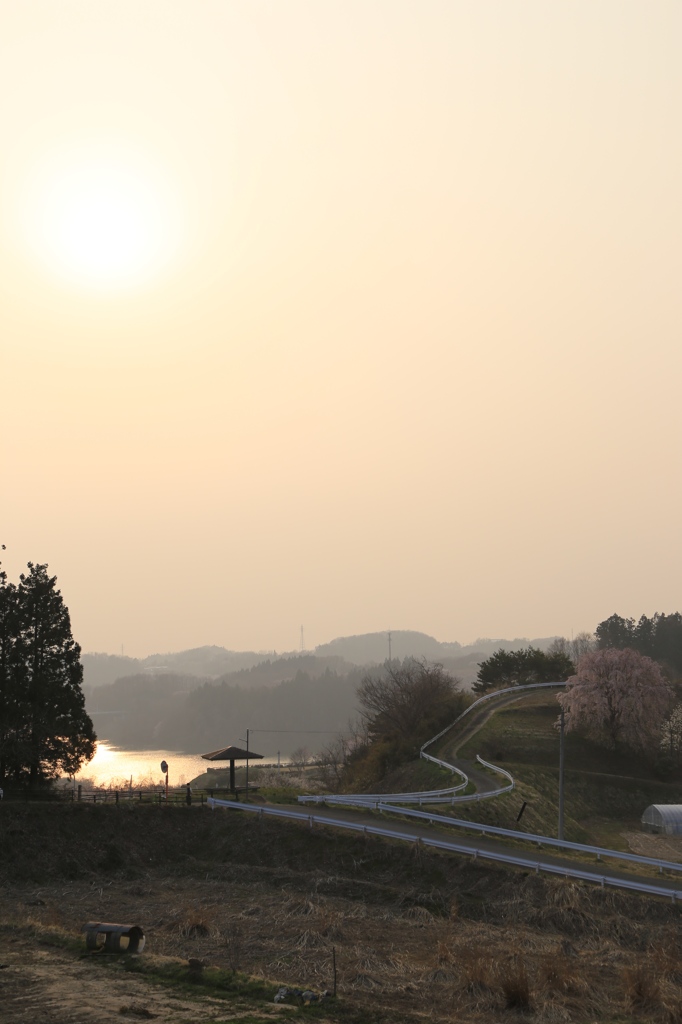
[83,630,551,756]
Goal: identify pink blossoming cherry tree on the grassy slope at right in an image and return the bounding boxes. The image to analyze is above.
[557,648,673,751]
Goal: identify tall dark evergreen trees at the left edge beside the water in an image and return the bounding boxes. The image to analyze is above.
[0,562,96,785]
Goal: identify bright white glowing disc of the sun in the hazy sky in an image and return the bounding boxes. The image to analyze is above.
[27,144,178,290]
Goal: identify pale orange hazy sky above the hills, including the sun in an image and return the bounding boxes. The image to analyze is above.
[0,0,682,654]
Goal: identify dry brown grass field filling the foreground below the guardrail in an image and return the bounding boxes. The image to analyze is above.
[0,804,682,1024]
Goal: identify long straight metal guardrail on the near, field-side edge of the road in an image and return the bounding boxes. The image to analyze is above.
[208,797,682,902]
